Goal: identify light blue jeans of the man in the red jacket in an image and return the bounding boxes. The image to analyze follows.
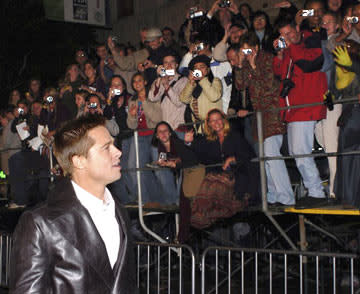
[287,121,325,198]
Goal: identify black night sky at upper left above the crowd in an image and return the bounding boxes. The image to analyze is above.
[0,0,95,106]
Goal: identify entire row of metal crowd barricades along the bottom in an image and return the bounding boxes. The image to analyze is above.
[0,233,360,294]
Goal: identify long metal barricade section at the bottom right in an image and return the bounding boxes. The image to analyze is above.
[201,247,360,294]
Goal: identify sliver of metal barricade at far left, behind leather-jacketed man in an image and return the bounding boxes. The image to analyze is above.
[0,232,12,287]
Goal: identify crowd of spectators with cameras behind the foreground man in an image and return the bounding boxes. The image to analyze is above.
[0,0,360,227]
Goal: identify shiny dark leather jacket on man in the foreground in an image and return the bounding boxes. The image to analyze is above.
[10,179,137,294]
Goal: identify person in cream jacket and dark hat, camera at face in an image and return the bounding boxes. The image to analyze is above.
[180,55,222,132]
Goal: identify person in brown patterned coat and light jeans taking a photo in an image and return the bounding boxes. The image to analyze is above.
[235,33,295,205]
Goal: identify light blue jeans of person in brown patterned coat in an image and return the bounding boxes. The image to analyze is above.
[264,135,295,205]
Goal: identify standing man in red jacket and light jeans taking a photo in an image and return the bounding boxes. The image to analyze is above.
[273,20,327,208]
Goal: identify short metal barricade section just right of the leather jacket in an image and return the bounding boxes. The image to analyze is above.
[136,242,195,294]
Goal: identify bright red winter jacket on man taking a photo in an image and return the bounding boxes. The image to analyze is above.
[273,32,327,122]
